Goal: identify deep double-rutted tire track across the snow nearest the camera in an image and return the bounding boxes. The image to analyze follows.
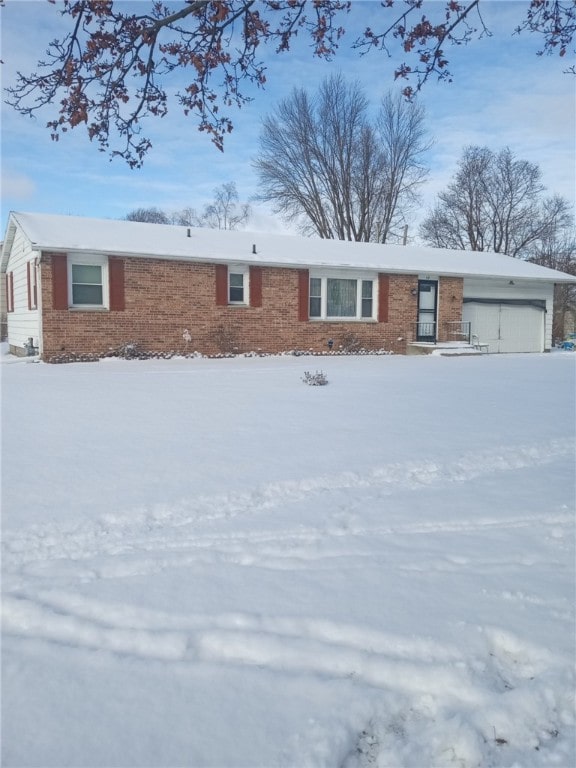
[2,592,569,708]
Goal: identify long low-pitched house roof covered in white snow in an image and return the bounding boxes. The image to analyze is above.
[2,213,575,283]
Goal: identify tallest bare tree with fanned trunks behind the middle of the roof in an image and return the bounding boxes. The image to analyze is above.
[254,75,429,242]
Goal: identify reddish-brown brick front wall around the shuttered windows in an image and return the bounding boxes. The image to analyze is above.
[41,254,462,360]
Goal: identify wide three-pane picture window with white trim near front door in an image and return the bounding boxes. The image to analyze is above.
[309,273,378,320]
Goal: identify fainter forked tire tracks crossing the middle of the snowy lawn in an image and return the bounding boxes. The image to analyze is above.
[2,439,574,571]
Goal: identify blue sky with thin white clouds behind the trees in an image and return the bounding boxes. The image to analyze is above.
[0,0,576,239]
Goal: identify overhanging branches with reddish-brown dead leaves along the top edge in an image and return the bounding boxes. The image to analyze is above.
[5,0,576,167]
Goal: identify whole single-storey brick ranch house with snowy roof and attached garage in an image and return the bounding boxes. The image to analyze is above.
[1,213,574,361]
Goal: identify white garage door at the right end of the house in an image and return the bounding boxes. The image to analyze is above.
[462,302,545,352]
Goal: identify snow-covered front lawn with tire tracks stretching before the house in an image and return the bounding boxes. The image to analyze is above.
[2,353,576,768]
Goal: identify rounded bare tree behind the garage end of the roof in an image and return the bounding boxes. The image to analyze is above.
[420,146,572,258]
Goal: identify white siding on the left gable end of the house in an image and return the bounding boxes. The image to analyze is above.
[6,228,41,353]
